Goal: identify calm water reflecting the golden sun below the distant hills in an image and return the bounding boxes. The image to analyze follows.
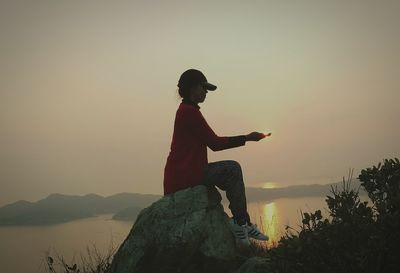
[0,197,326,273]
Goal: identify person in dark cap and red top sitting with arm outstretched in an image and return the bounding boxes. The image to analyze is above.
[163,69,270,245]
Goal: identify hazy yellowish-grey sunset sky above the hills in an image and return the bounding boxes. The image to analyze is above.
[0,0,400,205]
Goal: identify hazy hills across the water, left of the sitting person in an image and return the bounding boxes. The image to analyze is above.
[0,193,161,225]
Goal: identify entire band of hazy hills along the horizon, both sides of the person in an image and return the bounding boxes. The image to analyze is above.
[0,180,364,223]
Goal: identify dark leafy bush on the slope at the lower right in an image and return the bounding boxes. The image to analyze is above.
[265,158,400,272]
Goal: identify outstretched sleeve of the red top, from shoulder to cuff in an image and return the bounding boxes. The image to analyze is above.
[182,109,246,151]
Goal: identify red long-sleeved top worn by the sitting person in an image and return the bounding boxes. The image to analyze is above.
[164,100,246,194]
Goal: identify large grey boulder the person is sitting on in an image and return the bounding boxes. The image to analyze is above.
[111,185,247,273]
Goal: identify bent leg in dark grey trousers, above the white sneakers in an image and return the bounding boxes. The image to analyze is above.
[202,160,251,225]
